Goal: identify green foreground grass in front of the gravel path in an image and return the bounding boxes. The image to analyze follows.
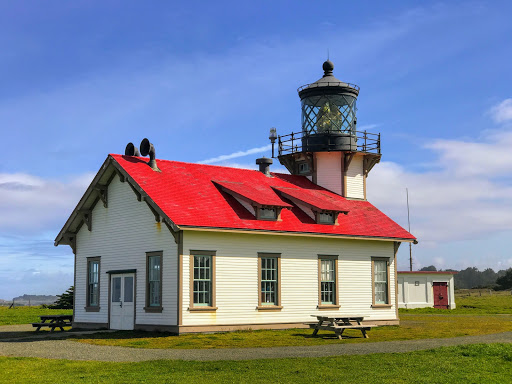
[0,344,512,384]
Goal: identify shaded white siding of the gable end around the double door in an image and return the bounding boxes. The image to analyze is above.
[75,176,177,325]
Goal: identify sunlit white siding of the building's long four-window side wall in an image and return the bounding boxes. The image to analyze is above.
[182,231,396,325]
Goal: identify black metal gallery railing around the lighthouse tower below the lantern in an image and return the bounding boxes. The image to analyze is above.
[277,131,380,156]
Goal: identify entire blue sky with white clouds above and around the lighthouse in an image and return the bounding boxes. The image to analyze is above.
[0,0,512,299]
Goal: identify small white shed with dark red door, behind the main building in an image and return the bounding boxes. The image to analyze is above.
[398,271,457,309]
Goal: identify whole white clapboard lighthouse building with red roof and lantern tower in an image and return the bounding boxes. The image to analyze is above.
[55,61,416,333]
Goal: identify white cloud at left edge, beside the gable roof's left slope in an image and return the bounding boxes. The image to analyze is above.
[0,173,93,234]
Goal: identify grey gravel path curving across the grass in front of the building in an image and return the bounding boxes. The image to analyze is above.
[0,327,512,362]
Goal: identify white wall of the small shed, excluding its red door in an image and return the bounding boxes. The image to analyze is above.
[398,273,455,309]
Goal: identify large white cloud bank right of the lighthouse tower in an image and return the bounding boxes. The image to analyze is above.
[368,132,512,246]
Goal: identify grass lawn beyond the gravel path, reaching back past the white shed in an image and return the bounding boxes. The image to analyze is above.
[70,291,512,349]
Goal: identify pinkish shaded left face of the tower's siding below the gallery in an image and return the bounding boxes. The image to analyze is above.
[315,152,343,195]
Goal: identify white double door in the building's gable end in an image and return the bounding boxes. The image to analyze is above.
[110,273,135,330]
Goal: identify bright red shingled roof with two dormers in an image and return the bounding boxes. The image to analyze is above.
[110,155,415,240]
